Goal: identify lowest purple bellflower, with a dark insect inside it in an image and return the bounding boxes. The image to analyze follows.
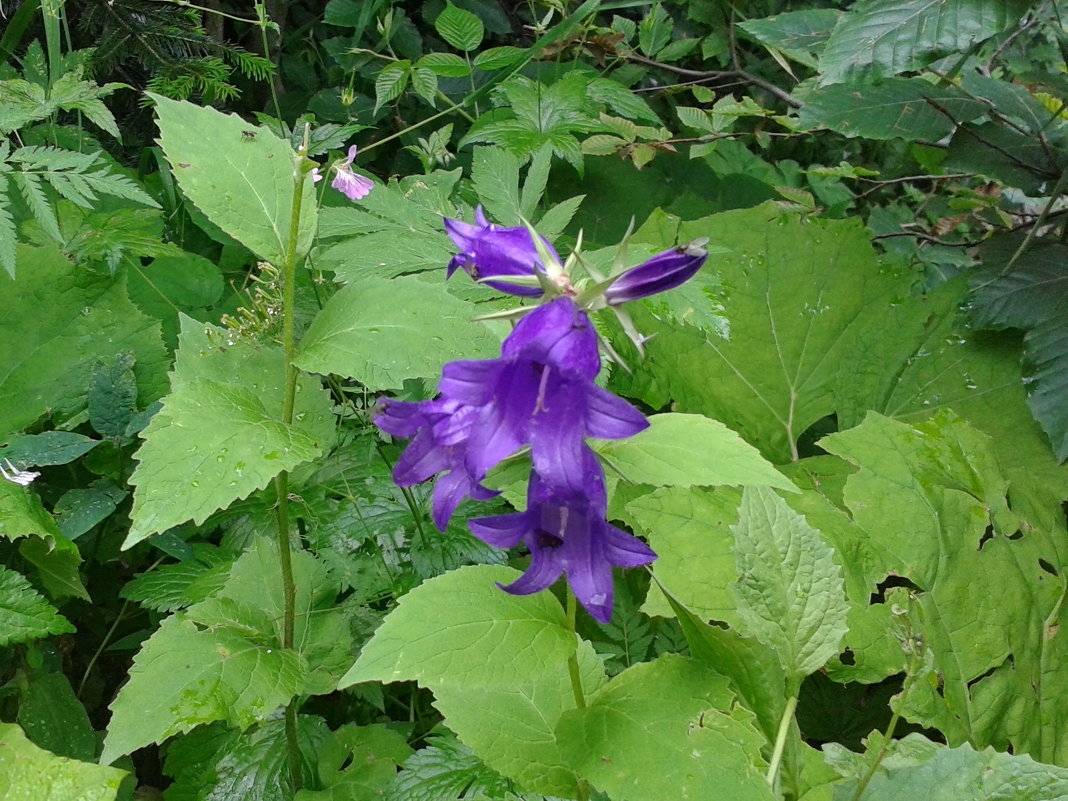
[470,447,657,623]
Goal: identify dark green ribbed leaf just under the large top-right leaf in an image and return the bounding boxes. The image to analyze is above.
[800,78,988,142]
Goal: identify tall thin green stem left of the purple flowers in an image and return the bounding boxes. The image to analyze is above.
[274,143,305,792]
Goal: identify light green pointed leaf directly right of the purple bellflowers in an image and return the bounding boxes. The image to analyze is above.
[595,413,795,490]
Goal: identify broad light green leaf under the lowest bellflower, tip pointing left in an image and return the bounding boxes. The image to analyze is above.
[339,565,575,689]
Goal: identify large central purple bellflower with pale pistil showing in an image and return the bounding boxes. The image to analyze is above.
[439,297,648,490]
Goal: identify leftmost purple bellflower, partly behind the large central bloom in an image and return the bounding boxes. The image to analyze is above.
[375,399,500,531]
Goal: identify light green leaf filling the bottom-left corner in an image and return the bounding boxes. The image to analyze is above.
[0,723,128,801]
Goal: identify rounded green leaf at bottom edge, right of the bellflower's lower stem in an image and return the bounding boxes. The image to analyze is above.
[556,655,773,801]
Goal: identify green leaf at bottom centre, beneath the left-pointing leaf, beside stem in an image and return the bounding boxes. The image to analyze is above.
[433,640,606,798]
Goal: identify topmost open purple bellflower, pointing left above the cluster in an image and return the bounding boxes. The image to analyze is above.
[443,206,560,298]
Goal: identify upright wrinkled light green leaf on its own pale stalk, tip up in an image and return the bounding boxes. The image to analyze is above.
[731,487,847,686]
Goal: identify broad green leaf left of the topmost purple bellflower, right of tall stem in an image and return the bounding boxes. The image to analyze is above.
[296,277,499,389]
